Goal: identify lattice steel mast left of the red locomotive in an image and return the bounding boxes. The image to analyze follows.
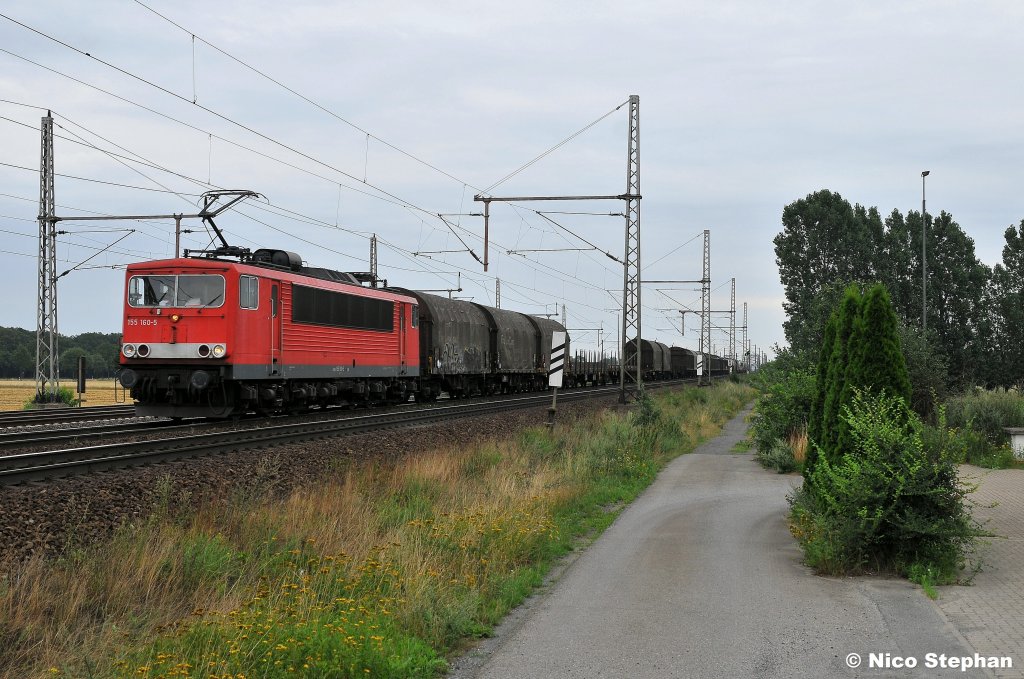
[36,111,60,401]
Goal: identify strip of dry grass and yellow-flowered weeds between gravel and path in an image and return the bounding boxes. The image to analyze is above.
[0,383,753,679]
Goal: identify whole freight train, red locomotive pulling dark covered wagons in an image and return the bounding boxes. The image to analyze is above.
[119,241,722,418]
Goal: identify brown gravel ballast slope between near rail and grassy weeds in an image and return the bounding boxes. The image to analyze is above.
[0,396,616,572]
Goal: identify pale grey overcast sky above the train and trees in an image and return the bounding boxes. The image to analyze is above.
[0,0,1024,354]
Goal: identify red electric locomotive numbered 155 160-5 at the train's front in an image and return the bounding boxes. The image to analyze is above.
[120,250,420,418]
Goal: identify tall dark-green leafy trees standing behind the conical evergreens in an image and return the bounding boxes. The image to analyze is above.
[774,189,1024,391]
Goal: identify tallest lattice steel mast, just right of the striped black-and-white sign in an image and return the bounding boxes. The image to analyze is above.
[618,94,643,404]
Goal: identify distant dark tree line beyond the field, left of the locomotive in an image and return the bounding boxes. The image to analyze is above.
[0,327,121,379]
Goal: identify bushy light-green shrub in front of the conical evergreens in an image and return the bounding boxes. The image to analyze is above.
[790,391,981,583]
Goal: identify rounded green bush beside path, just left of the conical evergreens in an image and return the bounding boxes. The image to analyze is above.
[751,369,814,455]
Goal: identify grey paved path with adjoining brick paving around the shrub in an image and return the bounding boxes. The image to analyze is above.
[451,411,1024,679]
